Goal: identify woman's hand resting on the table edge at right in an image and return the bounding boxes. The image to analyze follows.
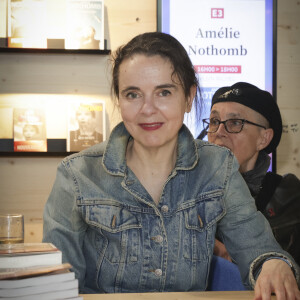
[254,259,300,300]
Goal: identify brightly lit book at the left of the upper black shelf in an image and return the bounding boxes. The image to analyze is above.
[7,0,47,48]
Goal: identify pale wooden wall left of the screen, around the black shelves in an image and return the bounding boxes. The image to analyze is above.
[0,0,156,242]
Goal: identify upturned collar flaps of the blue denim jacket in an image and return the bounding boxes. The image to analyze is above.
[102,122,198,176]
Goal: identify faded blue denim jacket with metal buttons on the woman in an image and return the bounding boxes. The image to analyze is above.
[44,123,298,293]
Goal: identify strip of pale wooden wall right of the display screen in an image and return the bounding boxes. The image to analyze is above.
[277,0,300,178]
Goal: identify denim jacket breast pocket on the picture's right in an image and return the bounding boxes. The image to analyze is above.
[183,191,225,261]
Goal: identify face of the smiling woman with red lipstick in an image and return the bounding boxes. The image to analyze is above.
[119,54,194,148]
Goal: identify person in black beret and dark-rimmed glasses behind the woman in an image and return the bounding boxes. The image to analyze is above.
[203,82,300,264]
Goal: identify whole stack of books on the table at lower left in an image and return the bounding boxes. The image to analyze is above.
[0,243,83,300]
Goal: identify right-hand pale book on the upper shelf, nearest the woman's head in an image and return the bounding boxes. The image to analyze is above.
[65,0,104,50]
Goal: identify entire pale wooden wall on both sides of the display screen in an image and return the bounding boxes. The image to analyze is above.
[0,0,300,242]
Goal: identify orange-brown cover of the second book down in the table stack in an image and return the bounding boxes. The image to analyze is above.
[0,263,72,280]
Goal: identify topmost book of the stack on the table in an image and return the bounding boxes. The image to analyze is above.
[0,243,62,268]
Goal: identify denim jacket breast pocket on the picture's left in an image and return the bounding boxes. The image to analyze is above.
[85,203,142,263]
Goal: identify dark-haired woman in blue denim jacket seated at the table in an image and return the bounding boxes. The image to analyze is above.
[44,33,300,299]
